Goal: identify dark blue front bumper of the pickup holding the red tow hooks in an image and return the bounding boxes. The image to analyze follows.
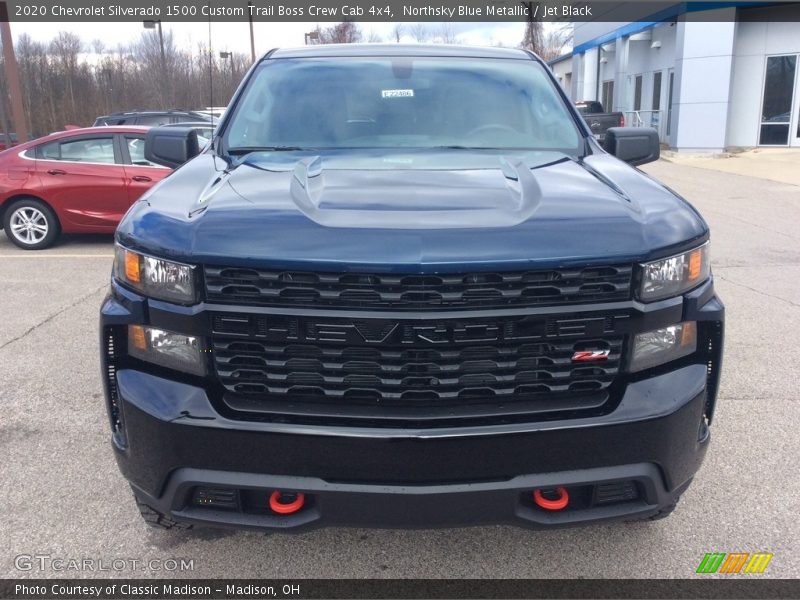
[101,284,723,530]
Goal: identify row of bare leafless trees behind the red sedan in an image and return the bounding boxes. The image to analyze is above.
[0,31,250,136]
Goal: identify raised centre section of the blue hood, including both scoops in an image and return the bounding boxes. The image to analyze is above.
[290,156,542,229]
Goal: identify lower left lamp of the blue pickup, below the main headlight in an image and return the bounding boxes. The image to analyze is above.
[128,325,206,375]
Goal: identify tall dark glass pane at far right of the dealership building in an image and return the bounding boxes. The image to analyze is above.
[758,55,797,146]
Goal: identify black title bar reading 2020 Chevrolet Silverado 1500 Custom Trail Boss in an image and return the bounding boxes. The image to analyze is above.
[6,0,800,23]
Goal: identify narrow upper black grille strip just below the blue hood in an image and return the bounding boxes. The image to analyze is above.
[205,265,631,310]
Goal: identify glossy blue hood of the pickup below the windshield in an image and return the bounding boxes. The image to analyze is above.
[117,150,707,272]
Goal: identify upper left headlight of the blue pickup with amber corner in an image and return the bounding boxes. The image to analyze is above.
[114,246,197,304]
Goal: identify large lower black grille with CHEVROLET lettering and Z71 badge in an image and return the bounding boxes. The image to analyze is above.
[211,311,628,424]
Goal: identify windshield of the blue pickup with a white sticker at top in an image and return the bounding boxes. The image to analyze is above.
[223,57,582,155]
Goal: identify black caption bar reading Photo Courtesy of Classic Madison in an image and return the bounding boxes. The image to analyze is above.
[0,577,800,600]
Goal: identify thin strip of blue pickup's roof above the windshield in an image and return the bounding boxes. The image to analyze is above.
[264,43,531,60]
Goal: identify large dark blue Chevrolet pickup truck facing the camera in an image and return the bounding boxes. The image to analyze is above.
[100,44,724,530]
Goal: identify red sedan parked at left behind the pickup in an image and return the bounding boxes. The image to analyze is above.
[0,127,171,250]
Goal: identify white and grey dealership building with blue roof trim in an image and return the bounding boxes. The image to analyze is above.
[550,2,800,153]
